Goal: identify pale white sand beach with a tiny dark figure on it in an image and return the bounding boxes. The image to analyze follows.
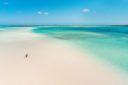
[0,27,128,85]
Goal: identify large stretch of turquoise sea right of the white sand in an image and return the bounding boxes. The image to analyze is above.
[32,26,128,72]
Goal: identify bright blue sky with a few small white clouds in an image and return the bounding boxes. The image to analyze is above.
[0,0,128,25]
